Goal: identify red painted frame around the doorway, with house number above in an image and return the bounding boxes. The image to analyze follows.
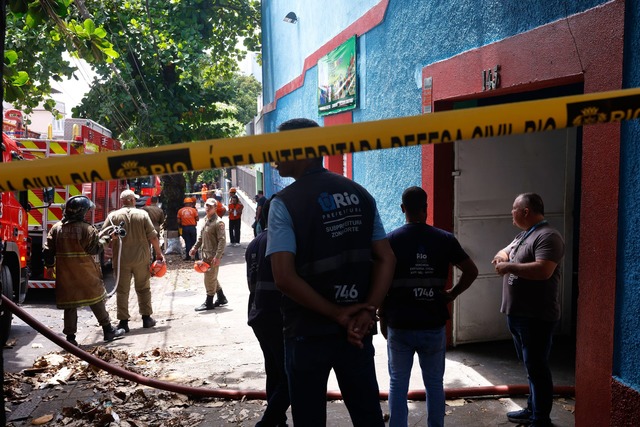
[422,0,624,426]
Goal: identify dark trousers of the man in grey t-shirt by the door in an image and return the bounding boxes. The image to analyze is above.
[507,316,557,423]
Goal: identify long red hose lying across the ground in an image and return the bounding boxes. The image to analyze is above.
[2,295,575,400]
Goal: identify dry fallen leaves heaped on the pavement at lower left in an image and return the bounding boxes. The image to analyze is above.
[5,346,264,427]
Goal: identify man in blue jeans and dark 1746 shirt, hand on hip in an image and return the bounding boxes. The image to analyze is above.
[380,187,478,427]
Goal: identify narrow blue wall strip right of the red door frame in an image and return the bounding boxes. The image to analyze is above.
[613,0,640,391]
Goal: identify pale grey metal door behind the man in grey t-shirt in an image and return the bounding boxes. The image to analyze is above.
[453,129,576,345]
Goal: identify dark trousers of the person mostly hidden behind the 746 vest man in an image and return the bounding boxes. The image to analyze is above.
[251,322,289,427]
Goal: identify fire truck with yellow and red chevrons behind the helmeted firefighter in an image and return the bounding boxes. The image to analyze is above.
[8,119,127,289]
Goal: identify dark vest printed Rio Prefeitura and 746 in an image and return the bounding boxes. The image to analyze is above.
[277,168,376,336]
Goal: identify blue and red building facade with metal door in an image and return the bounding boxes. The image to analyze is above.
[262,0,640,426]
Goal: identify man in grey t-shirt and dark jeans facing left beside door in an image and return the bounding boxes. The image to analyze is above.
[492,193,564,427]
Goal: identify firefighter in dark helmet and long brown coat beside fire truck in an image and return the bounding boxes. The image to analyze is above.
[43,196,124,346]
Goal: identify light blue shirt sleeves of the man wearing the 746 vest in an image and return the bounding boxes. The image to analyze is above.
[267,197,387,256]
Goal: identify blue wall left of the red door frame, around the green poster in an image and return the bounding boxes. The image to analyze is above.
[263,0,604,230]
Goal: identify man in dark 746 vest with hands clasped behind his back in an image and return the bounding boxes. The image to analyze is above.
[267,119,395,427]
